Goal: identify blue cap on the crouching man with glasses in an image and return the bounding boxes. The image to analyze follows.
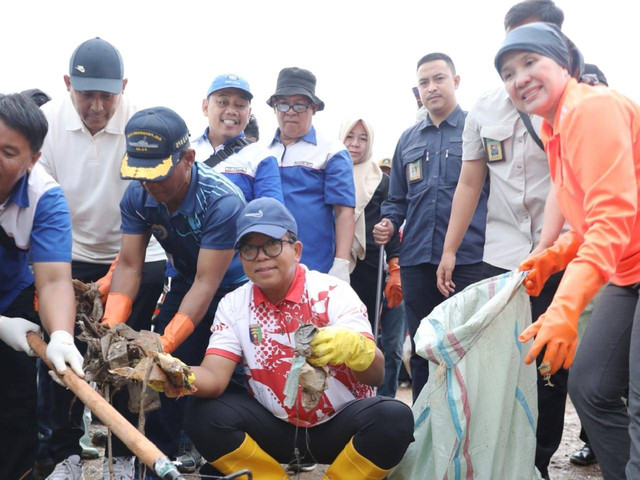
[235,197,298,248]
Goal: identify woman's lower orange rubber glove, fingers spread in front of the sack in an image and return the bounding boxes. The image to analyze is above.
[518,262,605,375]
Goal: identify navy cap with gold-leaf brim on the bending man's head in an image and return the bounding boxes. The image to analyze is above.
[120,107,189,182]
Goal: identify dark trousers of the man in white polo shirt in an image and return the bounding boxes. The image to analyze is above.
[47,261,166,463]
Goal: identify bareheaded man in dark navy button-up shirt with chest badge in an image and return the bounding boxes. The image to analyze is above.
[374,53,488,400]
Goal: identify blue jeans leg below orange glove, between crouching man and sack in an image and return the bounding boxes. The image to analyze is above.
[378,300,407,398]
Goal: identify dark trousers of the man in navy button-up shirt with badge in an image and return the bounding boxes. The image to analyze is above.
[400,263,484,402]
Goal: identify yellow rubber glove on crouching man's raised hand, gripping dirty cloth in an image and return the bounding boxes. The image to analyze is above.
[307,326,376,372]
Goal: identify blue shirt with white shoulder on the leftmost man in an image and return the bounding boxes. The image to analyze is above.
[0,164,71,314]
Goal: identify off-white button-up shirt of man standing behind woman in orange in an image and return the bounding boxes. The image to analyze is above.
[462,88,551,270]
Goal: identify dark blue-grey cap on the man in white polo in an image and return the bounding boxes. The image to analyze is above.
[69,37,124,95]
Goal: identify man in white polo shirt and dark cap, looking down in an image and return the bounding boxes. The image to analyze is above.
[40,38,166,480]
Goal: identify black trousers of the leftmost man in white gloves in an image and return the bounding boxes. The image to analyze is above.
[0,285,40,480]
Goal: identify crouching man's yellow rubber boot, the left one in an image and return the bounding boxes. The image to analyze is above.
[210,434,288,480]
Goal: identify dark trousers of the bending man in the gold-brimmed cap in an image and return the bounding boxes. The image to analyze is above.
[146,275,246,457]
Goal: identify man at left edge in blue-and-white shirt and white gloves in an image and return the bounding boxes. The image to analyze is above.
[0,94,84,480]
